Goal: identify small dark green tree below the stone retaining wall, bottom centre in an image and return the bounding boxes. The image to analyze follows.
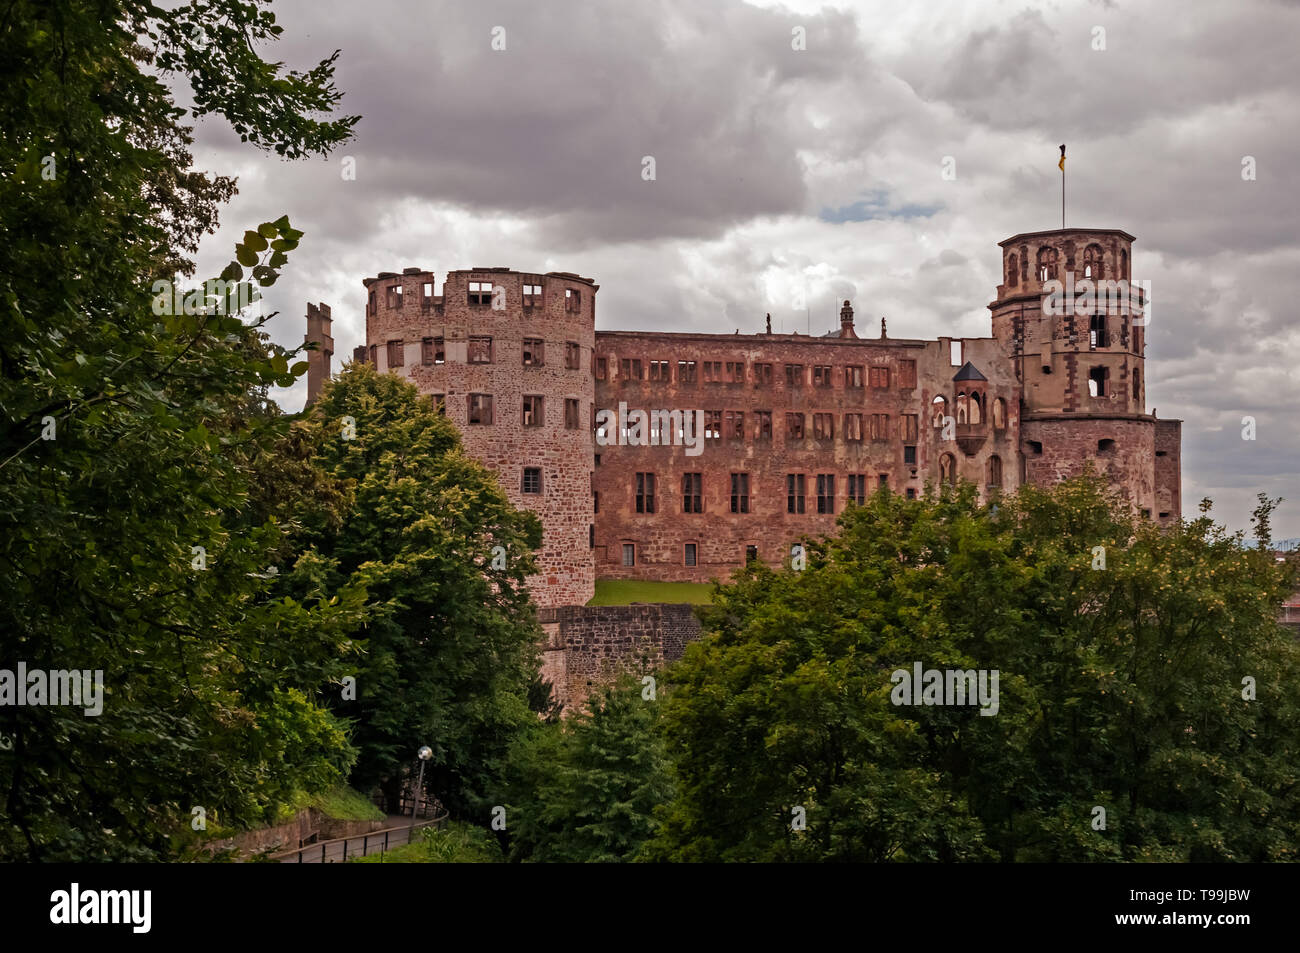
[507,680,672,863]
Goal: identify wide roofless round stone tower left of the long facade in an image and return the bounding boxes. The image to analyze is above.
[364,268,599,607]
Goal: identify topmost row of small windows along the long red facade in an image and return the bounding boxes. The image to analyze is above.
[594,356,917,390]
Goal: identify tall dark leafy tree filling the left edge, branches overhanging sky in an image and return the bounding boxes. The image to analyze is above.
[0,0,360,861]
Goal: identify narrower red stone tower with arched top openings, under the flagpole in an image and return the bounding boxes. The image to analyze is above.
[988,229,1167,516]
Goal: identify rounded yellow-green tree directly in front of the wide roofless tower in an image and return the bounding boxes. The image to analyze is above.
[298,364,542,820]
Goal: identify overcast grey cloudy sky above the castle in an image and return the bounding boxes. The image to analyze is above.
[185,0,1300,537]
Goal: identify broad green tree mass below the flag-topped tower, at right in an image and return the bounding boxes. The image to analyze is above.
[649,475,1300,861]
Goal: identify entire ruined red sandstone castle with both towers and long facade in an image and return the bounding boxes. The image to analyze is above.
[307,229,1180,696]
